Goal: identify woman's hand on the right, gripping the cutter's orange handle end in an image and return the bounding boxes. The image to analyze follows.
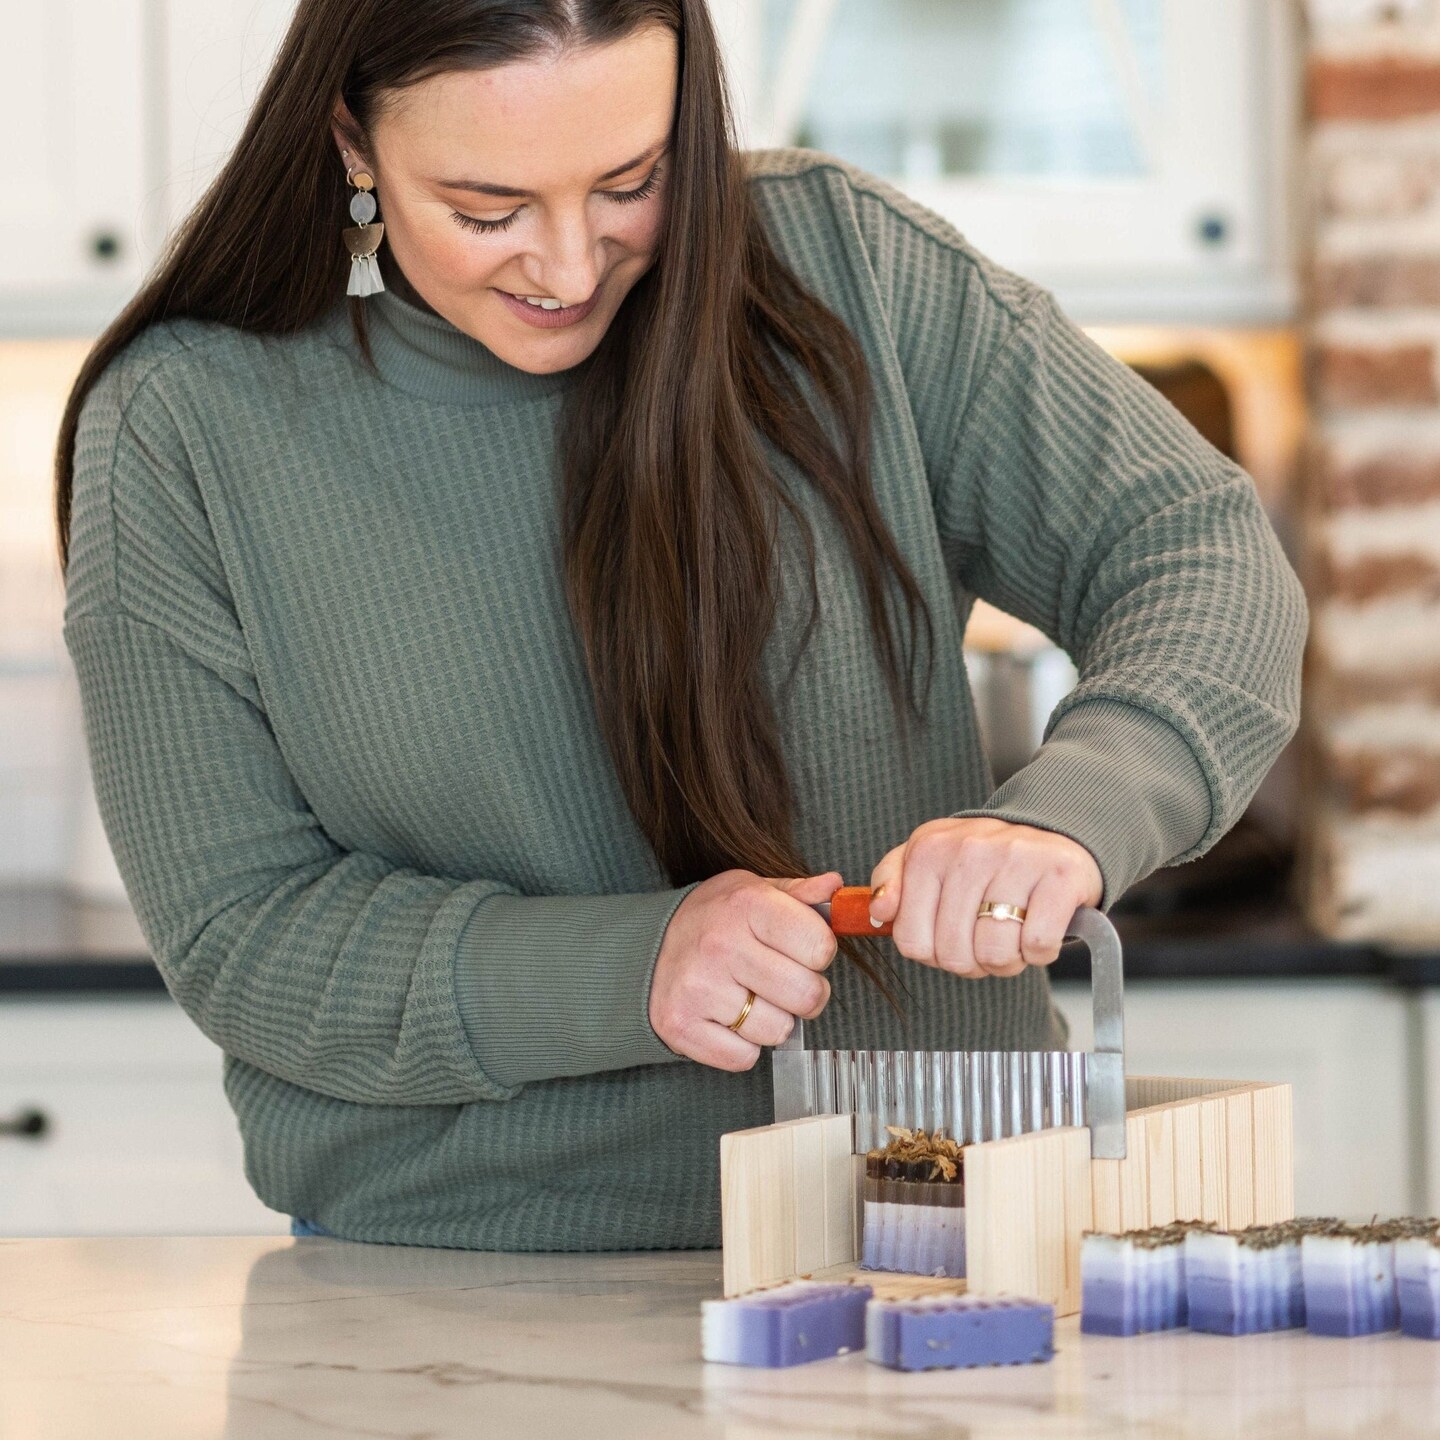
[870,816,1104,979]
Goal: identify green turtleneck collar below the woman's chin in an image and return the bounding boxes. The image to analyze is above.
[351,289,585,405]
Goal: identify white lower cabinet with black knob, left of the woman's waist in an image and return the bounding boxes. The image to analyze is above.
[0,995,288,1236]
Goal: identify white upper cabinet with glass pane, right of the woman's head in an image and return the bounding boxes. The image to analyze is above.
[711,0,1300,324]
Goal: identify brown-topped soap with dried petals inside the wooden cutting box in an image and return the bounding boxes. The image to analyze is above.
[860,1125,965,1279]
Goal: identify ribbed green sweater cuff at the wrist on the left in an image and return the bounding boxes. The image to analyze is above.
[455,880,700,1086]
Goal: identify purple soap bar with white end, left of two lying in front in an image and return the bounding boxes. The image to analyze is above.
[700,1280,873,1369]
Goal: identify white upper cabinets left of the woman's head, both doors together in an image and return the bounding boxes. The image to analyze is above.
[0,0,293,336]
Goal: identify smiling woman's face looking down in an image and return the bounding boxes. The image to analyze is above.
[336,26,678,374]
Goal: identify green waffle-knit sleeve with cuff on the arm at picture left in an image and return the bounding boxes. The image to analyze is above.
[65,339,694,1104]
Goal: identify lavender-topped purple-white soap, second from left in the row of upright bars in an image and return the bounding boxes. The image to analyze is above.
[1185,1220,1339,1335]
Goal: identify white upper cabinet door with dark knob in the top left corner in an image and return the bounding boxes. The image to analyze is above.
[0,0,153,333]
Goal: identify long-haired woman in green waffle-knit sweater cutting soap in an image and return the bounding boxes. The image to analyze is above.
[58,0,1305,1250]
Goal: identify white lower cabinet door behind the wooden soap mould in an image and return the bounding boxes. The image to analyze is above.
[1054,981,1423,1220]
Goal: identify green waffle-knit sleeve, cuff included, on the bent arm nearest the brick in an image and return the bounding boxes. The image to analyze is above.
[935,287,1308,904]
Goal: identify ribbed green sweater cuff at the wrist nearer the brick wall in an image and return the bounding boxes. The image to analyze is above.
[952,700,1211,910]
